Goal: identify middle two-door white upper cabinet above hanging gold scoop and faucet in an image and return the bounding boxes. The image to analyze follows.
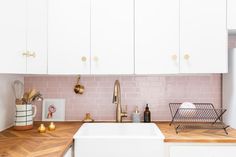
[48,0,134,74]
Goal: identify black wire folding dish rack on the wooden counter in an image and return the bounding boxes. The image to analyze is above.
[169,103,229,135]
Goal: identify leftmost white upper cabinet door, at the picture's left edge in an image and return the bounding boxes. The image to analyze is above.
[0,0,27,73]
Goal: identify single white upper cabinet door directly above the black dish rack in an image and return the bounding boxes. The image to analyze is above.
[180,0,228,73]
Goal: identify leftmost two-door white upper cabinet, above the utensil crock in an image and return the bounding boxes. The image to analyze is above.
[0,0,47,74]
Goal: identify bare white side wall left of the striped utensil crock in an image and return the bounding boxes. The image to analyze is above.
[0,75,24,131]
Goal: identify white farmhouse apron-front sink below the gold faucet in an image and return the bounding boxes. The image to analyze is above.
[74,123,164,157]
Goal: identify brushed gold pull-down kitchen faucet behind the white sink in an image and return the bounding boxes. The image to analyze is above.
[112,80,127,123]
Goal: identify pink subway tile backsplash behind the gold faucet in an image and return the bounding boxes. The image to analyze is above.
[24,74,221,120]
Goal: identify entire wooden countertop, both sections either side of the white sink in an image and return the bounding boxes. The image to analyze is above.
[0,122,236,157]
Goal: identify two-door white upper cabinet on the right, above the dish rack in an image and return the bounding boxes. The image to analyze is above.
[135,0,228,74]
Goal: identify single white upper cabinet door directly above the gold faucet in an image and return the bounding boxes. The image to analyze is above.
[91,0,134,74]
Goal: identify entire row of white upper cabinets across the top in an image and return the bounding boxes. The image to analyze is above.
[0,0,230,74]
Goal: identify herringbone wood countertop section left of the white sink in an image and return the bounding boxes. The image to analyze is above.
[0,122,82,157]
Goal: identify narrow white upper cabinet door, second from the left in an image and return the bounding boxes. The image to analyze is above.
[26,0,47,74]
